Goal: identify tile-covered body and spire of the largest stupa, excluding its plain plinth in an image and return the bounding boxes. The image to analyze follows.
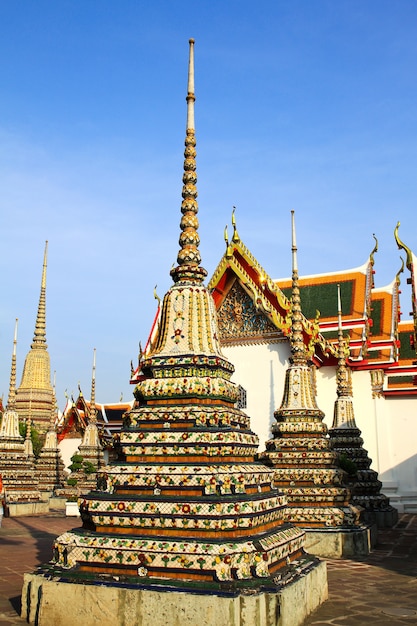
[49,40,317,592]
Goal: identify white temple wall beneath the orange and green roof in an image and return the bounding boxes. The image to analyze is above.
[222,342,417,512]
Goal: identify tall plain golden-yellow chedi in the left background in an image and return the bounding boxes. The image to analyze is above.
[16,242,53,433]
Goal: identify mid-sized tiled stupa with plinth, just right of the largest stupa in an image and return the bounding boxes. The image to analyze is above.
[260,211,369,556]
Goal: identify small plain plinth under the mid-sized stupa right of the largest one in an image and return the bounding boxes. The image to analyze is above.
[304,524,378,559]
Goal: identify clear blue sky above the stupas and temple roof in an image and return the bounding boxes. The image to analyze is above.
[0,0,417,408]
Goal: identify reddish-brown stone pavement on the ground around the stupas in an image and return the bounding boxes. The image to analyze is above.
[0,512,417,626]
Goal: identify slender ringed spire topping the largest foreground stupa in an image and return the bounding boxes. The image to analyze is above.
[170,39,207,282]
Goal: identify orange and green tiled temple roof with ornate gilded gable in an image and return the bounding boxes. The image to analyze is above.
[209,214,417,392]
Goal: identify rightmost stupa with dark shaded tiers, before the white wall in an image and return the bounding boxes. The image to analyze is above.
[329,285,398,528]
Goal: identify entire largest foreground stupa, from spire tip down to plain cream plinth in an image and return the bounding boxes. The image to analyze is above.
[22,40,327,626]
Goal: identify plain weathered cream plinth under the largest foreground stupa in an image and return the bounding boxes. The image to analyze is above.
[22,560,328,626]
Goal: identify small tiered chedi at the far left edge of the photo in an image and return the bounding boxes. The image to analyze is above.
[0,319,47,508]
